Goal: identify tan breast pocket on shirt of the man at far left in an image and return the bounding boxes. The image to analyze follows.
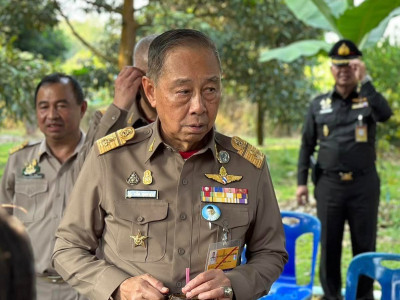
[14,178,48,223]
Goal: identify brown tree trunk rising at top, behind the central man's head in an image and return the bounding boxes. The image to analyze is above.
[118,0,138,70]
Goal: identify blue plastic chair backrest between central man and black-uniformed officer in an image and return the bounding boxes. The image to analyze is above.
[274,211,321,289]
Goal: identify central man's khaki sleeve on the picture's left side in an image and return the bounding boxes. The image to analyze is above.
[53,148,131,300]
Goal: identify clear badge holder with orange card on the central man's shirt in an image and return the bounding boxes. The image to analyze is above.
[205,228,241,272]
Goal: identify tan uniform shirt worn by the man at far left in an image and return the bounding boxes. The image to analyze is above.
[0,133,85,274]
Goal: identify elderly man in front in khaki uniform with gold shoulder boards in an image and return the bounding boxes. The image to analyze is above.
[53,29,287,300]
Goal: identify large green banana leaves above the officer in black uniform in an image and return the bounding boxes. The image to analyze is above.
[260,0,400,62]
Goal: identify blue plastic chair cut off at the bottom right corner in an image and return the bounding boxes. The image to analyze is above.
[346,252,400,300]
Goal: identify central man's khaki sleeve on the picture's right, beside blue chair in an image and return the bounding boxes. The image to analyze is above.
[226,162,288,299]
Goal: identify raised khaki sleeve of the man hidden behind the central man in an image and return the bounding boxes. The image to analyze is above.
[72,104,128,182]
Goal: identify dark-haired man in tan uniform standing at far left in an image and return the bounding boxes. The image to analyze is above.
[0,73,87,300]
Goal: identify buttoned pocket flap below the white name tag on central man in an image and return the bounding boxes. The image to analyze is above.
[115,200,168,224]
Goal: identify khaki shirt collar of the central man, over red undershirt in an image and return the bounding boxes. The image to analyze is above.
[146,117,217,161]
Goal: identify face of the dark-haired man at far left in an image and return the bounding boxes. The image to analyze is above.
[36,82,87,141]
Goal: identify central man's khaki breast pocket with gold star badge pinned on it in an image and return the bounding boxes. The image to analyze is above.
[115,200,168,262]
